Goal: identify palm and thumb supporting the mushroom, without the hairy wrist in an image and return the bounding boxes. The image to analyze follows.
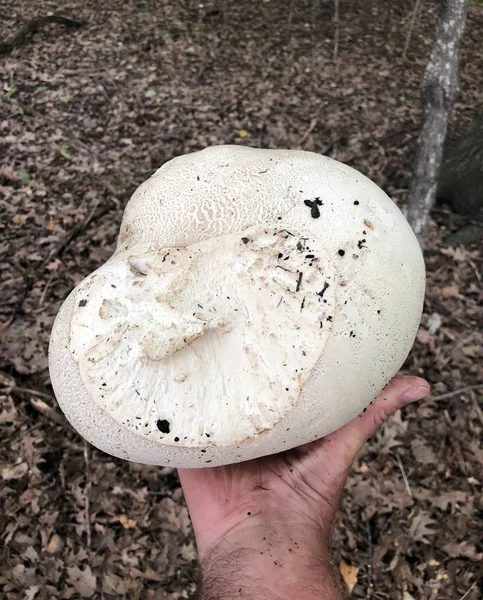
[179,377,429,555]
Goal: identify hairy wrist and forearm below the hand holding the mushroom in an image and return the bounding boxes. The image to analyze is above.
[199,524,345,600]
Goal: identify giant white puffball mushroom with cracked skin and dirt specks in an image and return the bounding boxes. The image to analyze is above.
[50,146,425,467]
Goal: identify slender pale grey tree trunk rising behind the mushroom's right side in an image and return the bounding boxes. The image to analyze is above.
[406,0,468,246]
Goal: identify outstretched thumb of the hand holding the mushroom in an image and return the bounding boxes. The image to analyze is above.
[320,376,430,471]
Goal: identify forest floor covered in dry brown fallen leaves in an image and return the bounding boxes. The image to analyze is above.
[0,0,483,600]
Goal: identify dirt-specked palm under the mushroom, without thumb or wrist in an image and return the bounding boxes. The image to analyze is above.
[180,438,345,546]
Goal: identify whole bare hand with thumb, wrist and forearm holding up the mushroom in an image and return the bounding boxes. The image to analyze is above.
[178,376,429,600]
